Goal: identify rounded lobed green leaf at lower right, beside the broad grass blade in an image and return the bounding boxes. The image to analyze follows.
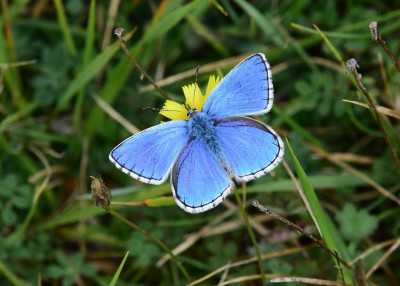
[336,204,378,242]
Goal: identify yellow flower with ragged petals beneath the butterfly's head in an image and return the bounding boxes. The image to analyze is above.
[160,75,220,120]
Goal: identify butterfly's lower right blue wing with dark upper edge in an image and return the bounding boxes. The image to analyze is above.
[215,117,284,182]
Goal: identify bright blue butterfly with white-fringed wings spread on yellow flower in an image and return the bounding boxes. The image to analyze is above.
[109,53,284,213]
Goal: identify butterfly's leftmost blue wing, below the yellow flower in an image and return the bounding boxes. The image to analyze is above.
[109,120,189,185]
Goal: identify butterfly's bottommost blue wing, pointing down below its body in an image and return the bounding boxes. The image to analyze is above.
[171,139,234,213]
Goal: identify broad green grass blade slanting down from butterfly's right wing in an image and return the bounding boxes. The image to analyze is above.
[285,138,354,284]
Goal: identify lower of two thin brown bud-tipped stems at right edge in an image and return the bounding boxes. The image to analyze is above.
[346,59,400,168]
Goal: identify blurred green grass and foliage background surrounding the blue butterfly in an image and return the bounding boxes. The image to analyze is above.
[0,0,400,285]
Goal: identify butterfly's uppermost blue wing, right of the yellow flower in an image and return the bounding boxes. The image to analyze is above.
[202,54,274,119]
